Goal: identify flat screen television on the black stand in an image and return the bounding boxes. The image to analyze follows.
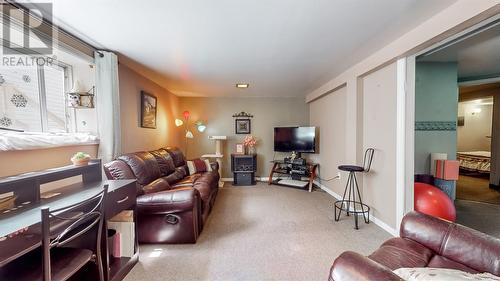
[274,127,316,153]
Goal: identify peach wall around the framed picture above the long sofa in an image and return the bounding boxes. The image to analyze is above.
[118,63,182,153]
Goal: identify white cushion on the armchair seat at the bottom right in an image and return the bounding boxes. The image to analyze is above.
[393,267,500,281]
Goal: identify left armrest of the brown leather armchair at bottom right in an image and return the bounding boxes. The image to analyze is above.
[328,251,403,281]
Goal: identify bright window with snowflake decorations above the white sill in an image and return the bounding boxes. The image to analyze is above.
[0,56,68,132]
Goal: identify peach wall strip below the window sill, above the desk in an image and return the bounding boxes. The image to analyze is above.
[0,145,97,177]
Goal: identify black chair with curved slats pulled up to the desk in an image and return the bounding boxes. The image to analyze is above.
[0,185,107,281]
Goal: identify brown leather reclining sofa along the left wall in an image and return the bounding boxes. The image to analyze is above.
[104,147,219,244]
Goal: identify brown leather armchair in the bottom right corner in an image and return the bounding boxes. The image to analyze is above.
[329,212,500,281]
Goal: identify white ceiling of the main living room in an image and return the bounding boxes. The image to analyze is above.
[43,0,455,97]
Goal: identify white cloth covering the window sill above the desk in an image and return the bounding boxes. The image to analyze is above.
[0,131,99,151]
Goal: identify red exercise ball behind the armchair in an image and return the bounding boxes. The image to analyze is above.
[414,182,457,222]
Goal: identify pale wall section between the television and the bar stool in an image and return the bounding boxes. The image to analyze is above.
[309,87,347,195]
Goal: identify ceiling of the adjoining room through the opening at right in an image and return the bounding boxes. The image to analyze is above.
[418,22,500,80]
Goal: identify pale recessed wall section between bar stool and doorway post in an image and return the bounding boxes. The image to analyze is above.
[363,63,397,228]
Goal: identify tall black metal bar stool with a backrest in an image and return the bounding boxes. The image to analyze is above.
[334,148,375,229]
